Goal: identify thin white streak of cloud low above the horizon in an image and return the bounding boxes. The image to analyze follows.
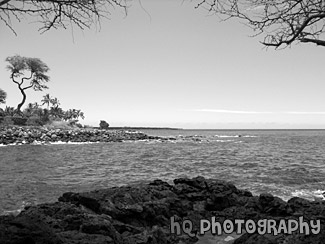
[190,109,325,115]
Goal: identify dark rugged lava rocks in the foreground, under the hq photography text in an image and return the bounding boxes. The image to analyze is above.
[0,177,325,244]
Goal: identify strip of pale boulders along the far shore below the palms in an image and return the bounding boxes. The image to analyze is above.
[0,126,164,145]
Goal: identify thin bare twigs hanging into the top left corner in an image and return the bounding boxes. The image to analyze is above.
[0,0,128,35]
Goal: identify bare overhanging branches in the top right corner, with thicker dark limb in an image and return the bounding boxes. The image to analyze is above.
[197,0,325,48]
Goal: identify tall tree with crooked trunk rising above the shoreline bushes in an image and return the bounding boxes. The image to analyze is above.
[6,55,50,112]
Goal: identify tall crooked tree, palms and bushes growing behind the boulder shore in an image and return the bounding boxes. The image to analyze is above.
[0,55,95,128]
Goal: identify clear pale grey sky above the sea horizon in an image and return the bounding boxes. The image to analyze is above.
[0,0,325,129]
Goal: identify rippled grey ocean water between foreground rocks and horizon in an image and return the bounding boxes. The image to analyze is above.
[0,130,325,214]
